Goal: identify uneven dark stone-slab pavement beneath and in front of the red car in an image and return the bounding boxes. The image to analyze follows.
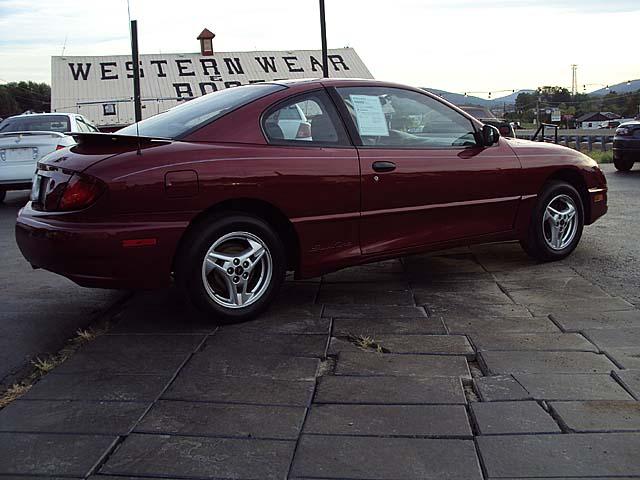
[0,244,640,480]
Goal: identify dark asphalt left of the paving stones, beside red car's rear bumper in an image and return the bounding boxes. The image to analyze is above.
[0,191,123,388]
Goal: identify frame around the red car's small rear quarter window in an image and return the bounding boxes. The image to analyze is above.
[260,87,354,148]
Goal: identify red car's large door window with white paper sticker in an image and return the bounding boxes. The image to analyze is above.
[337,87,476,148]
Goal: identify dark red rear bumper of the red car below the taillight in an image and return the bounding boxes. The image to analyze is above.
[15,203,187,289]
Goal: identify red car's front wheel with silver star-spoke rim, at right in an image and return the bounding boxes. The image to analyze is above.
[520,181,584,262]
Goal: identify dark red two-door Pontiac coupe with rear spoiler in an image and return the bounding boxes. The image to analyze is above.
[16,79,607,322]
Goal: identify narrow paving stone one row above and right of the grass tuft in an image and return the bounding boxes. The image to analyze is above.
[438,315,560,334]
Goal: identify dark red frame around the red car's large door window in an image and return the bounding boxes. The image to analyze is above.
[329,85,482,151]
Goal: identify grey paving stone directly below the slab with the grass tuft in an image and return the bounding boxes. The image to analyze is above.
[335,352,471,378]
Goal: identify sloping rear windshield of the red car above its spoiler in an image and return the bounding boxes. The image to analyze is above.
[118,83,287,138]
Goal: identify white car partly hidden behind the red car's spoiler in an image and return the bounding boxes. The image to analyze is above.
[0,113,98,202]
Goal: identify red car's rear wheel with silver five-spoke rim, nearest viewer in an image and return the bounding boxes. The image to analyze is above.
[175,213,287,324]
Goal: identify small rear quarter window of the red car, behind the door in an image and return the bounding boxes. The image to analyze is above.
[262,91,349,146]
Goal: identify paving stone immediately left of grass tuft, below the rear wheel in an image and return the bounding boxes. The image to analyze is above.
[203,330,328,357]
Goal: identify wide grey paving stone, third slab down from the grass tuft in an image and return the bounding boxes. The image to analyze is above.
[314,376,466,404]
